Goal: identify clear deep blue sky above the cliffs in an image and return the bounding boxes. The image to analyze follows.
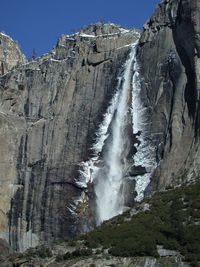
[0,0,160,57]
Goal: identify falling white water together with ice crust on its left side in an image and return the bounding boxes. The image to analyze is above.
[78,44,136,223]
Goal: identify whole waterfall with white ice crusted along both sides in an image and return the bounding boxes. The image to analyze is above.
[77,43,155,224]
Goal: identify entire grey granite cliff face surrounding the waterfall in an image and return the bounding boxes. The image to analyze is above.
[0,0,200,258]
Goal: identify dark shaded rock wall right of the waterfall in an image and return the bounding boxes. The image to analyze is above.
[138,0,200,189]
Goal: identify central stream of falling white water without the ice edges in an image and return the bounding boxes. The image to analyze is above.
[94,45,136,221]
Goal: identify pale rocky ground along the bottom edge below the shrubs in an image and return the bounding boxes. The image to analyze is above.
[0,241,192,267]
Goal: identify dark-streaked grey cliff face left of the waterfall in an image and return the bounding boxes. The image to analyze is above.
[0,24,139,251]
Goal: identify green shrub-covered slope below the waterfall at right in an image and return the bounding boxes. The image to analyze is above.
[83,182,200,264]
